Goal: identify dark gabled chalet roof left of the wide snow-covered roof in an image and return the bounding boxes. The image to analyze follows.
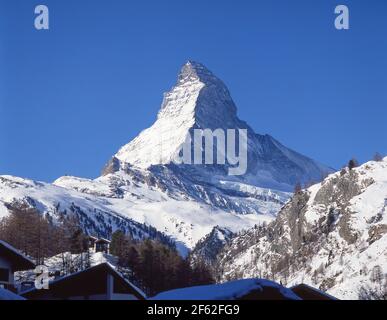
[22,262,146,299]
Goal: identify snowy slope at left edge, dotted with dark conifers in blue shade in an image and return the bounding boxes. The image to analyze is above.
[0,176,174,245]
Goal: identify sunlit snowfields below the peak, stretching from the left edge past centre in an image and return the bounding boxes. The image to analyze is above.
[0,174,272,255]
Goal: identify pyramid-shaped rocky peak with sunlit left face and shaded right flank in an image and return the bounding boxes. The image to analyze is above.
[107,61,332,191]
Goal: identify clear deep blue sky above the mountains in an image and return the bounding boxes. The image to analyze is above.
[0,0,387,181]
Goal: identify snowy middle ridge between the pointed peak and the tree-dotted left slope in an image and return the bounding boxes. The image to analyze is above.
[55,169,278,253]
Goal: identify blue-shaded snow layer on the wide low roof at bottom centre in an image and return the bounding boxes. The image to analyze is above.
[151,279,301,300]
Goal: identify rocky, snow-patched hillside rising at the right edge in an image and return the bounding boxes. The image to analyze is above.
[217,158,387,299]
